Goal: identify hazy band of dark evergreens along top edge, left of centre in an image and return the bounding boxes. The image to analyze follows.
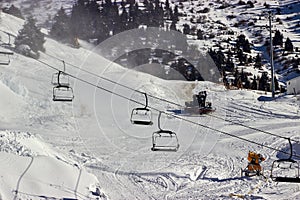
[50,0,179,44]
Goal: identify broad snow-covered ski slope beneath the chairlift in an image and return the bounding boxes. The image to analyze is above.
[0,13,300,199]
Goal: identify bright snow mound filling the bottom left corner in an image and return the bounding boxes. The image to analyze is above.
[0,130,106,199]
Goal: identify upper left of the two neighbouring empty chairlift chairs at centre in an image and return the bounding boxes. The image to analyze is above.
[130,93,153,125]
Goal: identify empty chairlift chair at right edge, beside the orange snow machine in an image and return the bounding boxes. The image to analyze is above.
[270,138,300,183]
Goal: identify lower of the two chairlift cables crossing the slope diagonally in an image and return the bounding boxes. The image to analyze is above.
[36,59,300,159]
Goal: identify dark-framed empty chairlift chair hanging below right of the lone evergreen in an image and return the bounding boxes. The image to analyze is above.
[53,71,74,101]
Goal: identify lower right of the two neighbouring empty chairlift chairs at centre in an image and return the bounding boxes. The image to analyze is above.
[151,112,179,152]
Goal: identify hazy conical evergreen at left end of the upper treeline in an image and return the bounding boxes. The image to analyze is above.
[50,7,72,42]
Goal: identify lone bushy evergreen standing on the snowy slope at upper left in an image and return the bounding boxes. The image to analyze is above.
[15,16,45,55]
